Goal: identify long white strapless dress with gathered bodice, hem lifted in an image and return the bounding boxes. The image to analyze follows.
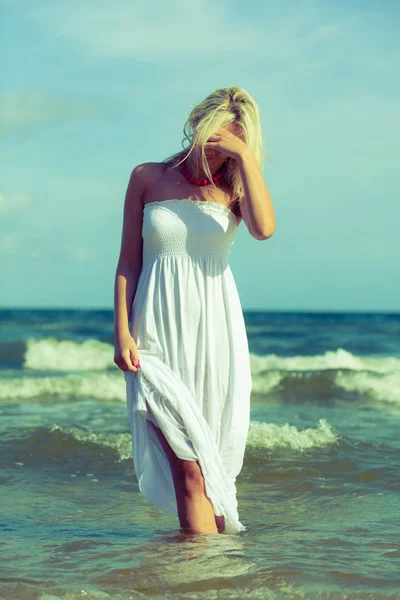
[124,199,252,533]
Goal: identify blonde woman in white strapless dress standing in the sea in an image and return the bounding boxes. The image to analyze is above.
[114,87,275,534]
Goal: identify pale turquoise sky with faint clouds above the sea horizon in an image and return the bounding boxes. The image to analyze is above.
[0,0,400,311]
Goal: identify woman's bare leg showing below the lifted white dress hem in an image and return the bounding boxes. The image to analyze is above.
[150,423,219,534]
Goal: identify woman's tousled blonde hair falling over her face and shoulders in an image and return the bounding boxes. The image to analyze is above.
[162,86,269,209]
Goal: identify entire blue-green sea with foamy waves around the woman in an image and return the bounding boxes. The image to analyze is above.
[0,310,400,600]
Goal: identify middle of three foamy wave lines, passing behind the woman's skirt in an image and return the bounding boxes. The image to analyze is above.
[0,369,400,408]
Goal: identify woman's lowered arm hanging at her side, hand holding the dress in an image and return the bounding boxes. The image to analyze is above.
[114,165,145,372]
